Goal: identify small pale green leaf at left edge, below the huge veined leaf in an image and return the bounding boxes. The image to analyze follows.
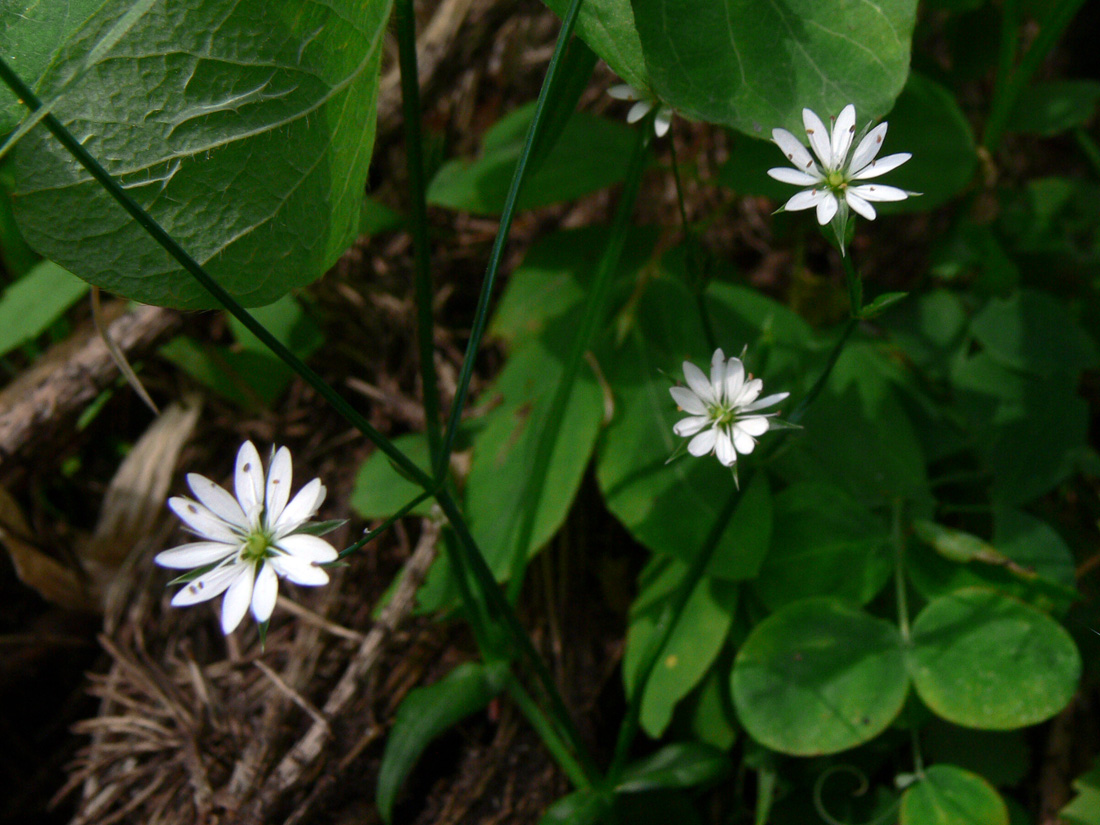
[0,261,89,355]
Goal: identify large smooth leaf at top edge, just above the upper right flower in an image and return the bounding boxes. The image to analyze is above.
[629,0,916,135]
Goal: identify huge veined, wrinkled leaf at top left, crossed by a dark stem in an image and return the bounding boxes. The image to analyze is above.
[9,0,389,307]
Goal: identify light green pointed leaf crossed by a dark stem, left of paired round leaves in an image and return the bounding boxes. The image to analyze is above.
[623,557,738,739]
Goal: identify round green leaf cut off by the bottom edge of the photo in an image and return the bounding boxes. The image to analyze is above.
[900,765,1009,825]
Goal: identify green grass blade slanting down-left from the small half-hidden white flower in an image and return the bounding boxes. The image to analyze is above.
[504,122,651,604]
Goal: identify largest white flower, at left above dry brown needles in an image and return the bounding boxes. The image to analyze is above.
[156,441,338,635]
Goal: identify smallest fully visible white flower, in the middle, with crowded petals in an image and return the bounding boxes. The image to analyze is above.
[669,350,790,466]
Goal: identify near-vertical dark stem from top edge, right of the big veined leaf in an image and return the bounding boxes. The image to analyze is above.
[394,0,441,466]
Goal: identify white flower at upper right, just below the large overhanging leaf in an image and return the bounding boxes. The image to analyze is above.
[768,103,914,227]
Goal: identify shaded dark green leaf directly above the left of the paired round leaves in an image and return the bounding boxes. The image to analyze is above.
[754,482,893,609]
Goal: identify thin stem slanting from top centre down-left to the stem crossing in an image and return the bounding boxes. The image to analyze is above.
[435,0,581,477]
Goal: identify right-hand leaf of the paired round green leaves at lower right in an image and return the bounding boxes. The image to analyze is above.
[909,587,1081,730]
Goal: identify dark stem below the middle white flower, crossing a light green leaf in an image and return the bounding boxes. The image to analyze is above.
[607,490,752,784]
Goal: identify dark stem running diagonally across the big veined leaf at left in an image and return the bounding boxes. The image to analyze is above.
[0,58,435,497]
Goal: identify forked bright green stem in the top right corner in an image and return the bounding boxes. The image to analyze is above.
[981,0,1085,153]
